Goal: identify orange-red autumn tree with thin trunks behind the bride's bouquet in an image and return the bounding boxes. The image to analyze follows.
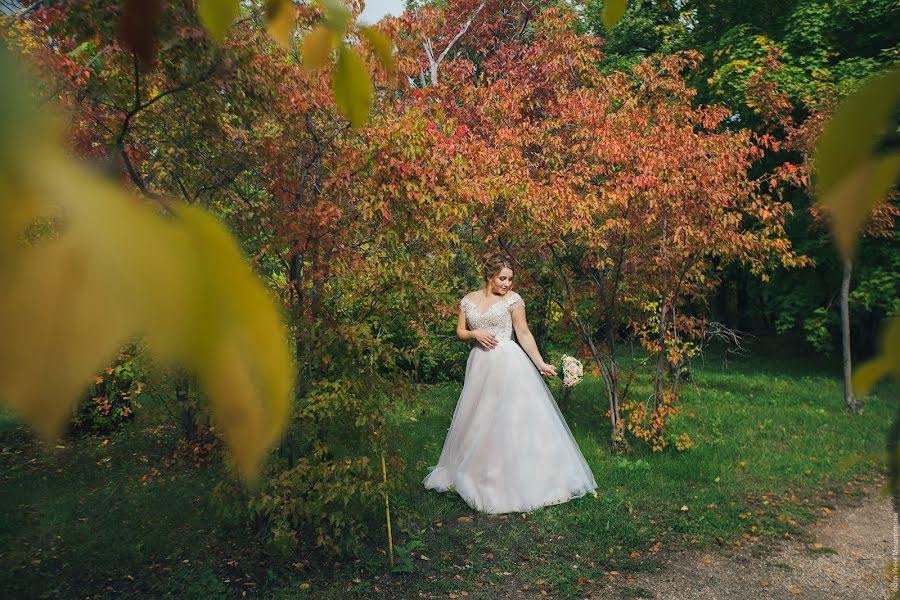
[394,9,802,448]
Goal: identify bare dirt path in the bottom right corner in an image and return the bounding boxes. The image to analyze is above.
[593,482,896,600]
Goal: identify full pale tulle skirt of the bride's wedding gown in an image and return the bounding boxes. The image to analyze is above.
[423,340,597,514]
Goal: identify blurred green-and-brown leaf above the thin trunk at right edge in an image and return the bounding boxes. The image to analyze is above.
[814,68,900,256]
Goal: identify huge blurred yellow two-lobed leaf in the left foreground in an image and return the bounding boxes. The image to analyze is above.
[0,50,293,477]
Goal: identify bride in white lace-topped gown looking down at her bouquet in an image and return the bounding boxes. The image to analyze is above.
[423,253,597,513]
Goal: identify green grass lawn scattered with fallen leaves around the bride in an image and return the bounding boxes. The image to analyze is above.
[0,344,898,598]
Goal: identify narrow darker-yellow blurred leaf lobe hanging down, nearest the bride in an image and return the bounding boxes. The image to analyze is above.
[178,206,292,474]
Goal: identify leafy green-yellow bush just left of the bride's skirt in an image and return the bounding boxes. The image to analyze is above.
[215,324,408,556]
